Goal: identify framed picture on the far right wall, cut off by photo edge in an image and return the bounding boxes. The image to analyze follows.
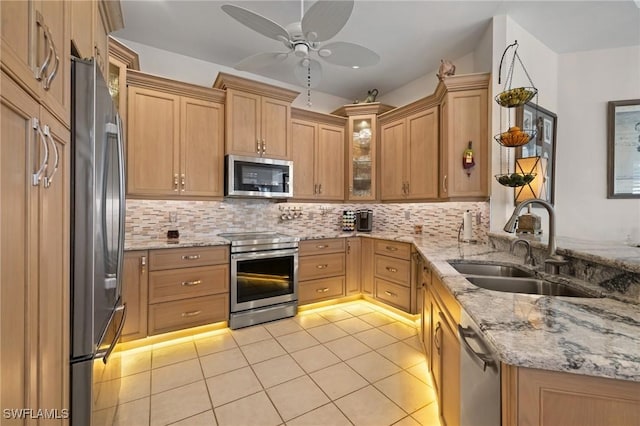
[607,99,640,198]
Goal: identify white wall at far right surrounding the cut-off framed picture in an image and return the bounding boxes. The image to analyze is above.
[556,46,640,242]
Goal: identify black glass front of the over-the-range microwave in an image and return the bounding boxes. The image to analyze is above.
[234,161,289,192]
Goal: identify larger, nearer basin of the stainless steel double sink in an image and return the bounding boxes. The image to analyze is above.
[465,276,600,297]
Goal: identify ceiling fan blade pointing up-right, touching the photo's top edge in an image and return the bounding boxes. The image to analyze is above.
[301,0,353,42]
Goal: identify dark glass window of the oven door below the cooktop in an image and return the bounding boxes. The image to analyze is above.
[237,256,293,303]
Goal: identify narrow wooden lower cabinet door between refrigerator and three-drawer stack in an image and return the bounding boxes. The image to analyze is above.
[120,250,149,342]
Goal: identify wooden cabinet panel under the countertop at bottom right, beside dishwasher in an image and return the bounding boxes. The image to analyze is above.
[502,364,640,426]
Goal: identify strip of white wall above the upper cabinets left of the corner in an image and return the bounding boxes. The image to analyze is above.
[112,38,352,112]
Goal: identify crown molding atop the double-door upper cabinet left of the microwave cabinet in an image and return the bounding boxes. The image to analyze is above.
[127,70,226,103]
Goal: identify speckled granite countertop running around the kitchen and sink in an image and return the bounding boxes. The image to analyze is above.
[125,231,640,382]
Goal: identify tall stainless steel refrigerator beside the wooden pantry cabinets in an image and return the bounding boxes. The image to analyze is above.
[70,58,126,426]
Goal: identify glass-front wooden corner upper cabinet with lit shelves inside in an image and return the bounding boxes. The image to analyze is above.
[334,102,393,201]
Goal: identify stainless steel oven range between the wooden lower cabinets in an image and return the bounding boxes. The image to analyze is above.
[220,232,300,329]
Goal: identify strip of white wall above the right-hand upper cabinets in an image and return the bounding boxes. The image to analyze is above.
[377,52,474,107]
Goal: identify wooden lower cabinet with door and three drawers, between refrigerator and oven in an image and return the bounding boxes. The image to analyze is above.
[121,246,229,342]
